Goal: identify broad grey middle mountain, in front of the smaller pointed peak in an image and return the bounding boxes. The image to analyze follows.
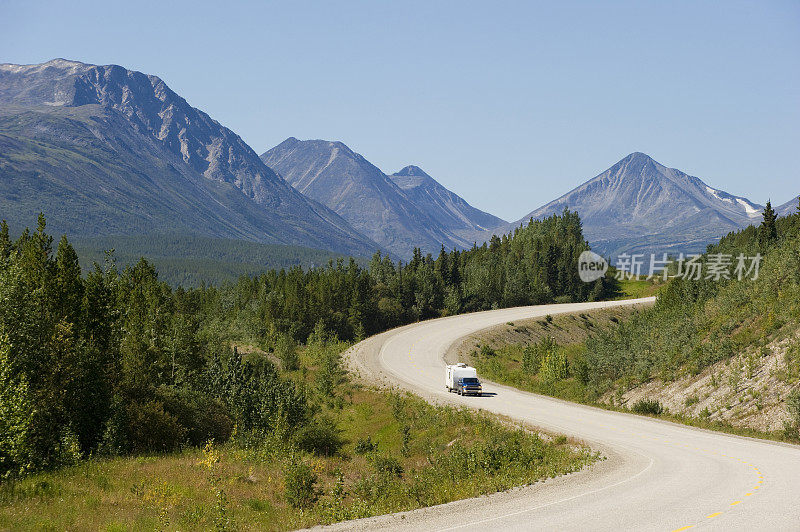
[261,138,476,258]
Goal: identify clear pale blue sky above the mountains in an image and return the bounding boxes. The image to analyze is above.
[0,0,800,220]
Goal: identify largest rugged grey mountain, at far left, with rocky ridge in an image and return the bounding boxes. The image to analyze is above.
[0,59,377,256]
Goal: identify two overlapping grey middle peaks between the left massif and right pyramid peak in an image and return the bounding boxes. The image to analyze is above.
[261,137,503,257]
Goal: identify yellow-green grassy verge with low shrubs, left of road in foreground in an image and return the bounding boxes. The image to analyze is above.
[0,343,597,530]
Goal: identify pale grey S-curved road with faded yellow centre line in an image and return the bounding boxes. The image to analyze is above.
[337,298,800,531]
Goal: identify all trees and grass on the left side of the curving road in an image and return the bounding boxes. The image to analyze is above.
[0,211,616,529]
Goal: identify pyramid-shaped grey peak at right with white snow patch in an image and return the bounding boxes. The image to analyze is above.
[512,152,763,259]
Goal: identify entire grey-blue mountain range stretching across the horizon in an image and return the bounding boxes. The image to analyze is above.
[0,59,798,274]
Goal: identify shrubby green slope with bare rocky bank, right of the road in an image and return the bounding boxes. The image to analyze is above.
[472,202,800,441]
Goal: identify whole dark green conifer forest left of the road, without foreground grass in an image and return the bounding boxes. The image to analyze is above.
[0,211,615,478]
